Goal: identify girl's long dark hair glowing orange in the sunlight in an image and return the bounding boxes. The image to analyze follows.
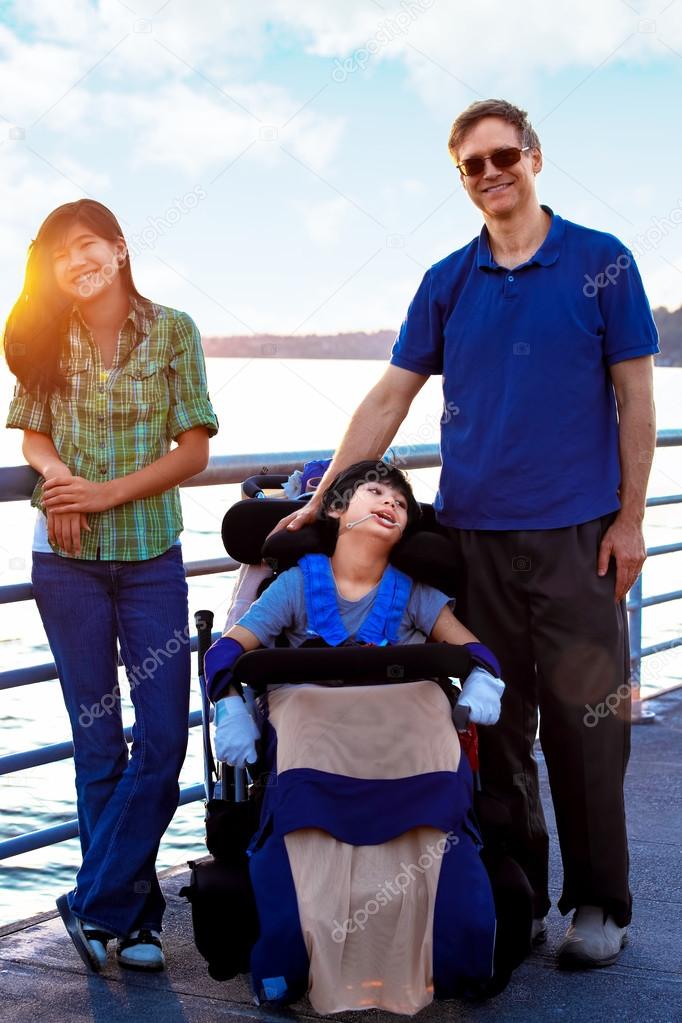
[3,198,145,395]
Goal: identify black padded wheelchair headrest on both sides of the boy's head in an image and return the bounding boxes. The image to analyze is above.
[222,498,459,596]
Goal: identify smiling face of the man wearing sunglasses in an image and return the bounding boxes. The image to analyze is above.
[457,118,542,219]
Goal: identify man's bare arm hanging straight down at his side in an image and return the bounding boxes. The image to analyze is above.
[597,355,656,602]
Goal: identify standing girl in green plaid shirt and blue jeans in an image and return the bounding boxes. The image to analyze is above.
[4,199,218,971]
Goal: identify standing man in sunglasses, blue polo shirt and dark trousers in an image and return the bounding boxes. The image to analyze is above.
[280,100,657,967]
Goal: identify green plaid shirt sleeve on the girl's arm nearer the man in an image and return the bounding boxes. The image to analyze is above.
[168,313,218,438]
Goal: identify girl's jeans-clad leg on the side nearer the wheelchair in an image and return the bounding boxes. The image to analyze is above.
[68,547,190,935]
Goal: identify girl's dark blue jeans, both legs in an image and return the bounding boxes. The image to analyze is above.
[33,546,190,936]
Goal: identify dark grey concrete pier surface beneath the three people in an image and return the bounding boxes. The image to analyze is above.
[0,691,682,1023]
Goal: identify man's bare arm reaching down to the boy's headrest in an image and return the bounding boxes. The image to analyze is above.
[277,365,428,529]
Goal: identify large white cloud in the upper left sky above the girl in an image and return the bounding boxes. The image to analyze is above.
[0,6,344,176]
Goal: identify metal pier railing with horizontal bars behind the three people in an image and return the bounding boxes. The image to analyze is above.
[0,430,682,859]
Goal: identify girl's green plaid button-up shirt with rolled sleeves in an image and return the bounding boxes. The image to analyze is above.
[7,300,218,562]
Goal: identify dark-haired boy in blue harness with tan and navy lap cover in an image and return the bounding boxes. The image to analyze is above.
[206,461,532,1015]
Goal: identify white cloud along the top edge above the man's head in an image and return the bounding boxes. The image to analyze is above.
[257,0,682,110]
